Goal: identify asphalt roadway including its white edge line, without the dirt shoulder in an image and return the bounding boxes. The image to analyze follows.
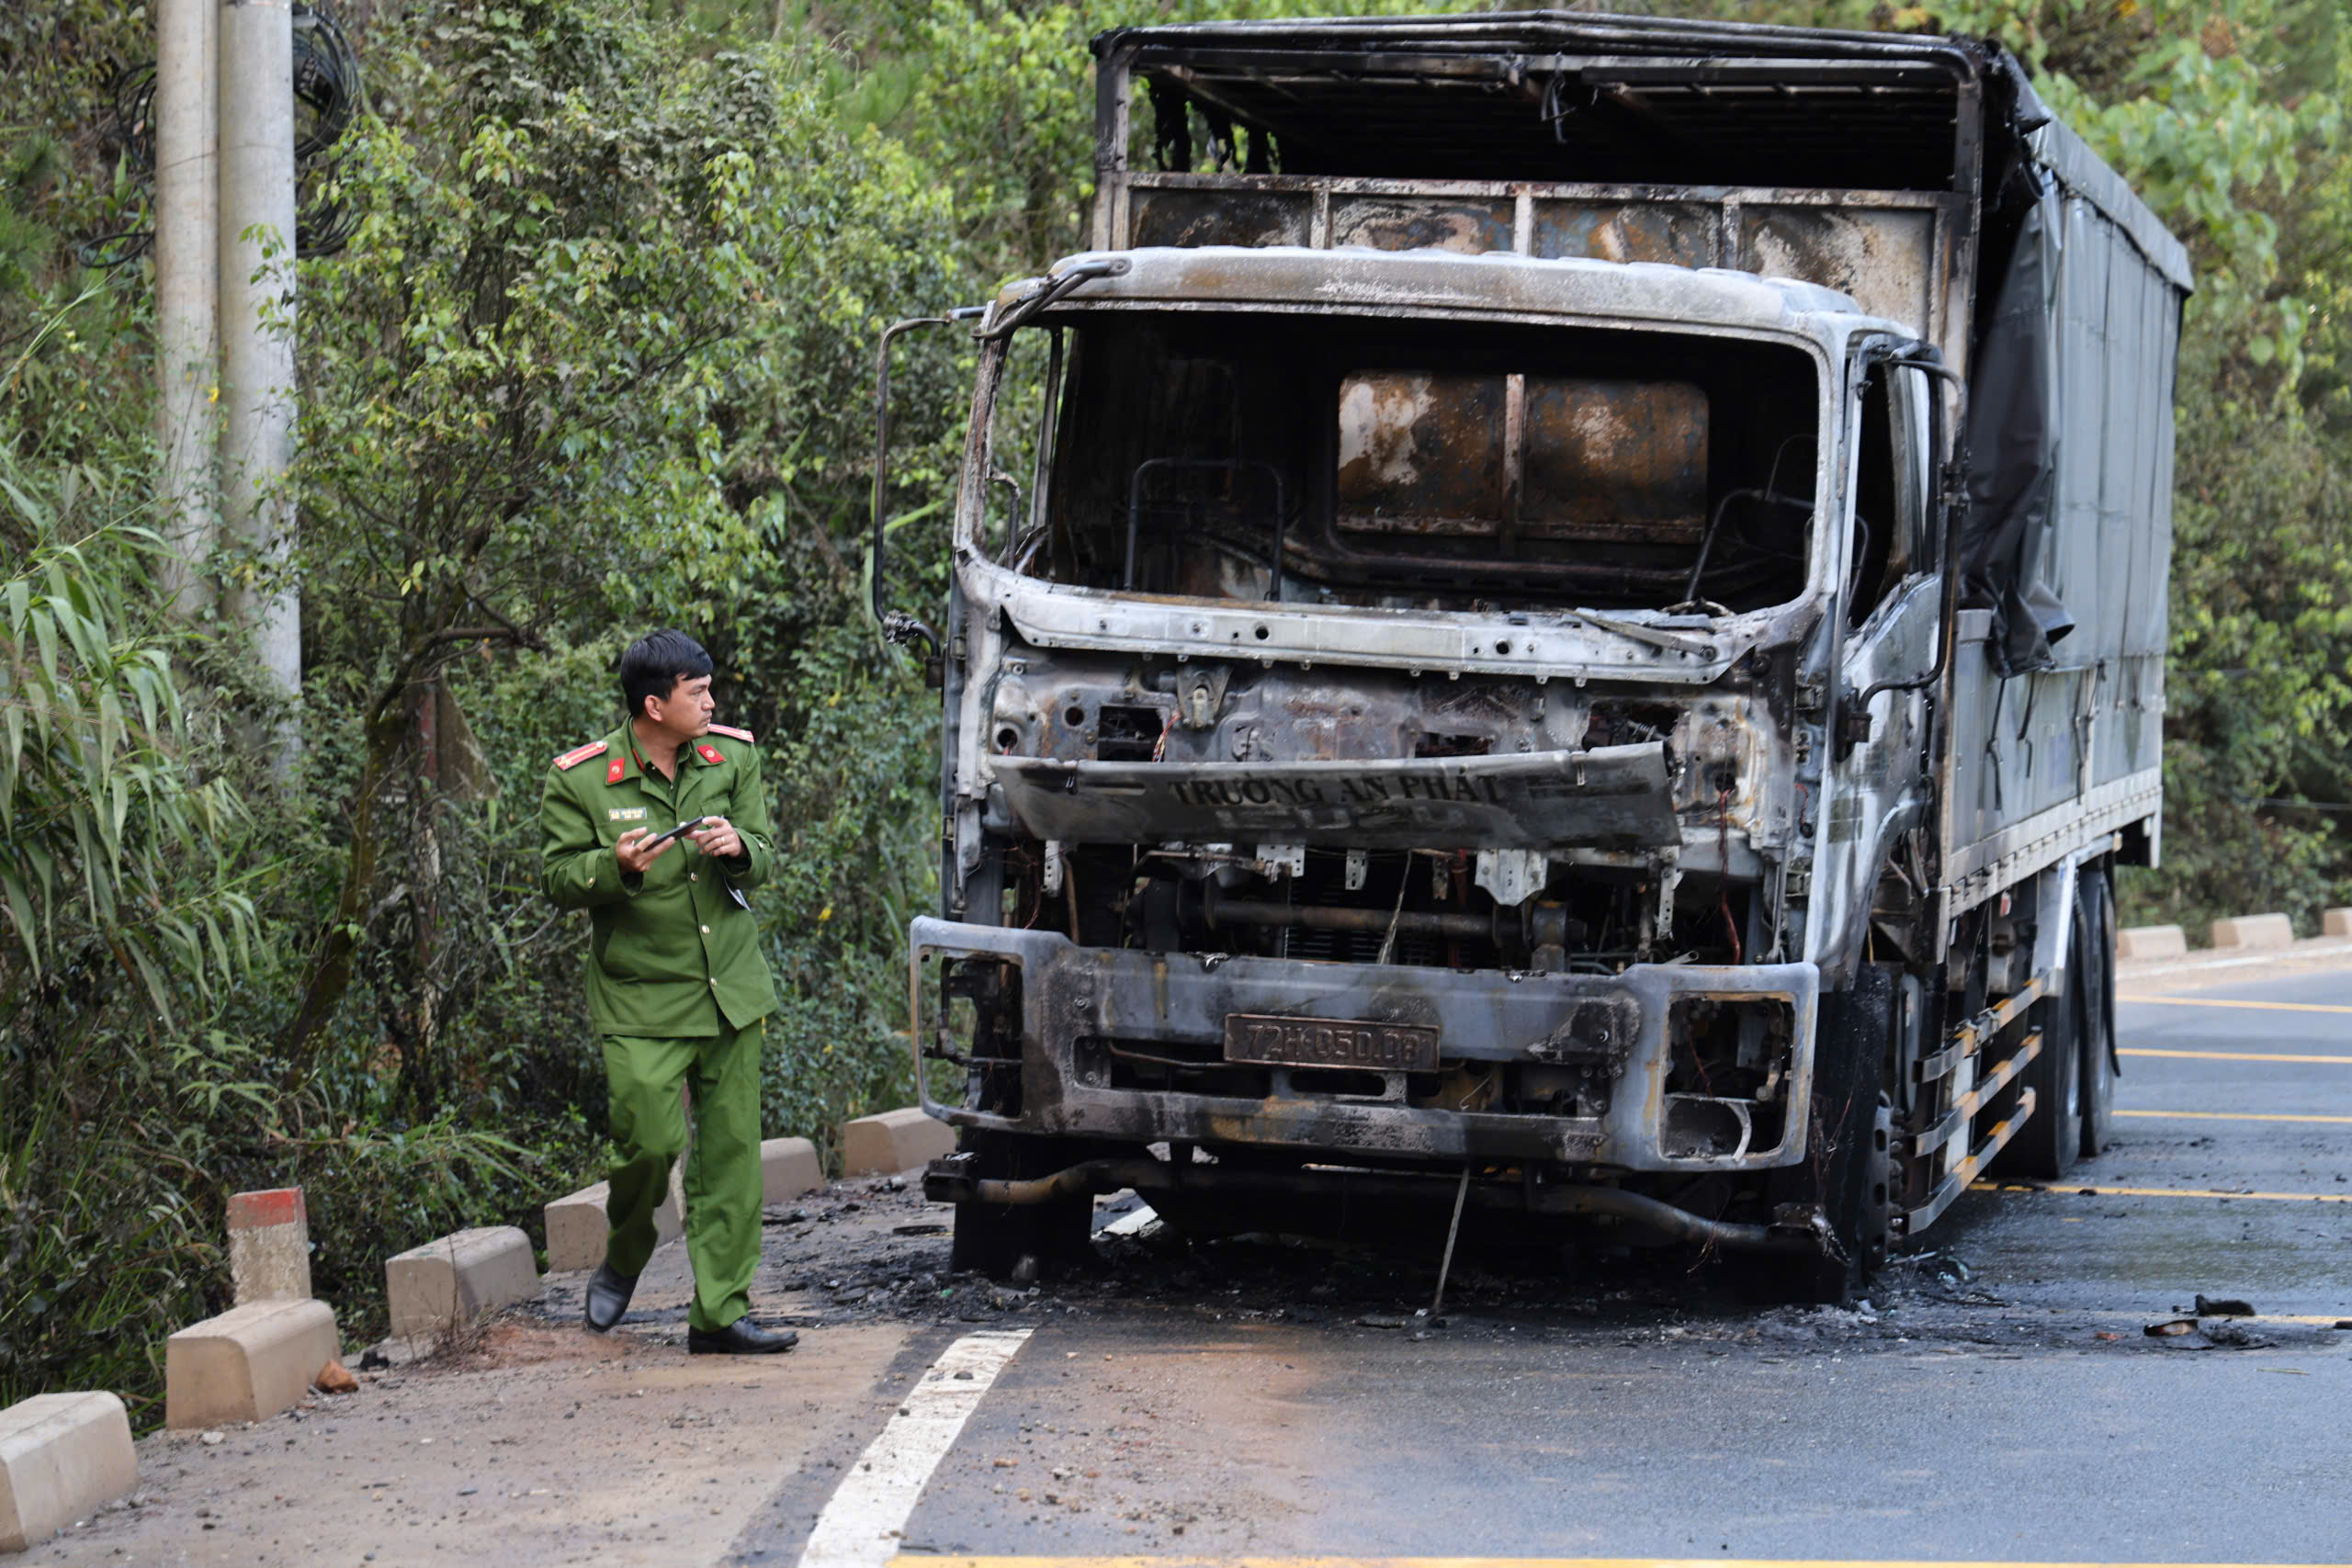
[727,971,2352,1568]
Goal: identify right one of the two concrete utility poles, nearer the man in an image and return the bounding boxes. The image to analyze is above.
[219,0,301,696]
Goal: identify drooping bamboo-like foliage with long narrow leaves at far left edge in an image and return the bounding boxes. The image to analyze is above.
[0,472,261,1404]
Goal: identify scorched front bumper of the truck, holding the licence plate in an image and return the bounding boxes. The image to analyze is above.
[910,919,1820,1170]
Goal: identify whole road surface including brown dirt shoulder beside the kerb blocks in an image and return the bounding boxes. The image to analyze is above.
[51,954,2352,1568]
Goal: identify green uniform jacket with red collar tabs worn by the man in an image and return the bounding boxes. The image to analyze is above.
[538,724,776,1039]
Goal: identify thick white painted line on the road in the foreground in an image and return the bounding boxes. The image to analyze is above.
[799,1328,1030,1568]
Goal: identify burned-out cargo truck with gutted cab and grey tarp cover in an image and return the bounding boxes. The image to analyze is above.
[875,12,2189,1298]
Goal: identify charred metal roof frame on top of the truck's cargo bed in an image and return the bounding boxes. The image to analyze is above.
[1093,12,2189,289]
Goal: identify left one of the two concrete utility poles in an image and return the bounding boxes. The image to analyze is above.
[155,0,221,621]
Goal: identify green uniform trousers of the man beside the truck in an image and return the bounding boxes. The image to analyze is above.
[605,1018,767,1331]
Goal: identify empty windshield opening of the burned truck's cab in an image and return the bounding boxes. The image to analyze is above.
[983,312,1818,614]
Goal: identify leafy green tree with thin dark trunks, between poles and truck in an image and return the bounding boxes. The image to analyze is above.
[282,0,823,1086]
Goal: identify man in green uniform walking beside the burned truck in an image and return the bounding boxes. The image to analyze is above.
[538,630,799,1357]
